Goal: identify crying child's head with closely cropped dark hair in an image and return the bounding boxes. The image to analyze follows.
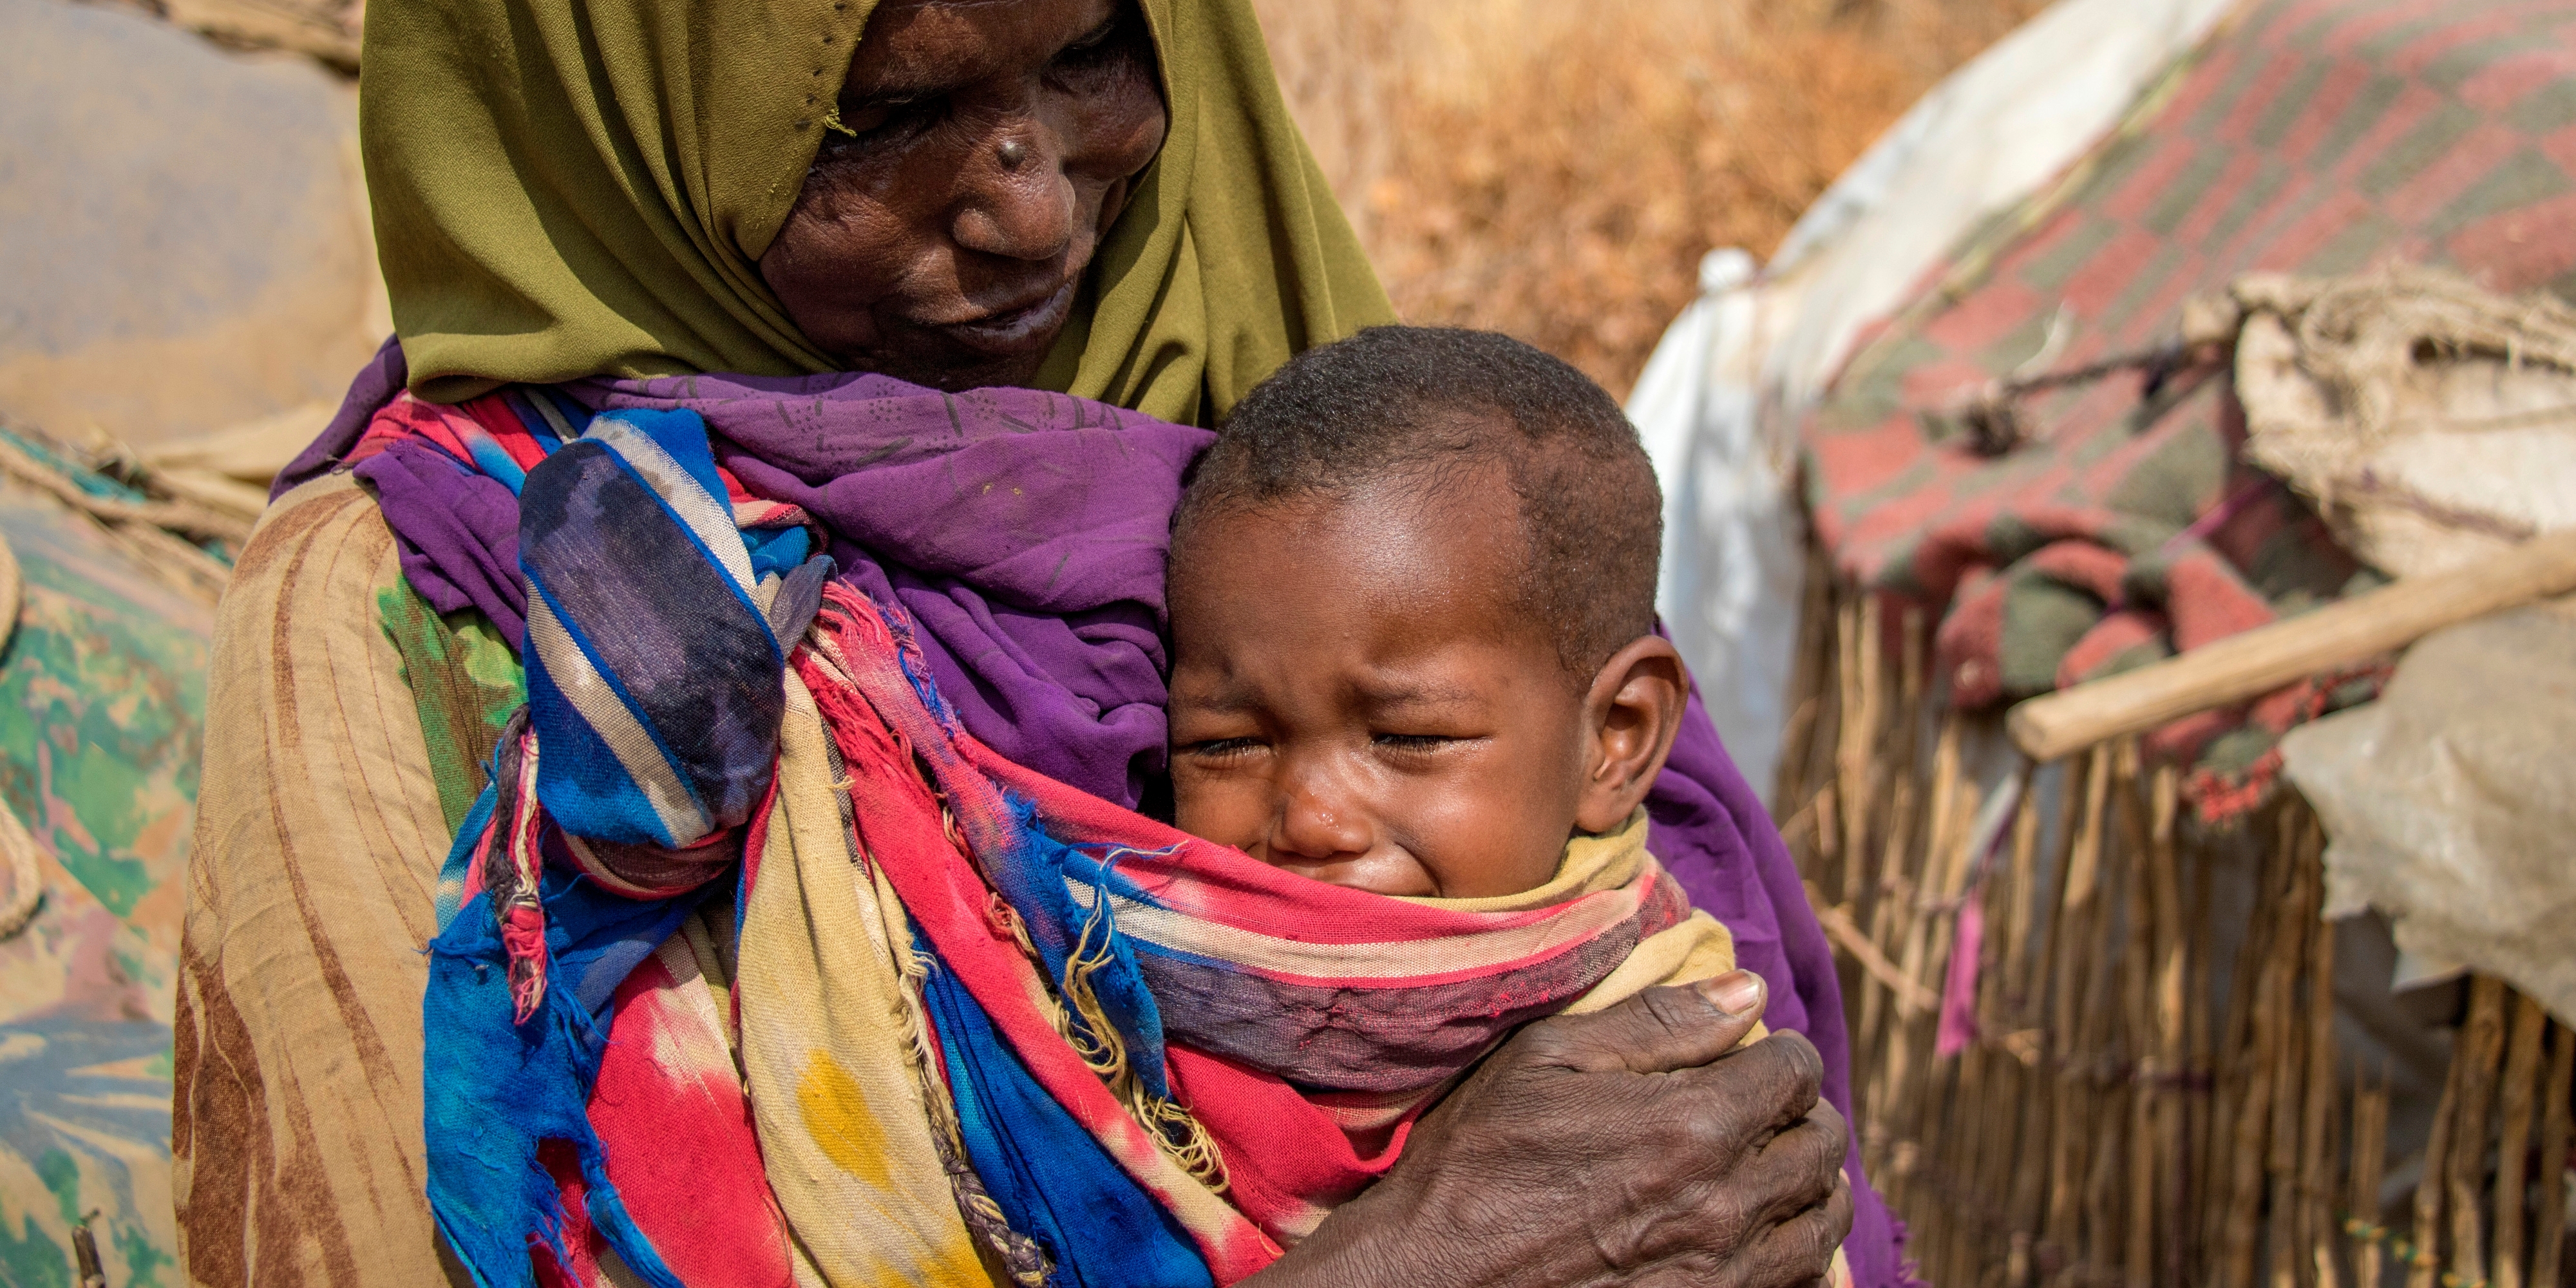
[1170,327,1690,899]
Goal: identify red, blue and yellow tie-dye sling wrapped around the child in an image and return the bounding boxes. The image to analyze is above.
[402,392,1731,1288]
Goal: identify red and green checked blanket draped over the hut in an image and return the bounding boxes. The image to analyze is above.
[1806,0,2576,817]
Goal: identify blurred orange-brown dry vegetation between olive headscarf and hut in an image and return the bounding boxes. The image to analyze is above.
[1252,0,2043,394]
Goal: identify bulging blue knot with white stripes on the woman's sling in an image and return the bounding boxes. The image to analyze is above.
[518,412,799,848]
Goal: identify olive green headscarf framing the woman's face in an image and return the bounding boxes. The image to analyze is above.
[358,0,1394,425]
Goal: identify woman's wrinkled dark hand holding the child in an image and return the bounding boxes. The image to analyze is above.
[1249,971,1852,1288]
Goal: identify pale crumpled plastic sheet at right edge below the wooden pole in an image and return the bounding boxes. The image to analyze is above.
[2282,603,2576,1023]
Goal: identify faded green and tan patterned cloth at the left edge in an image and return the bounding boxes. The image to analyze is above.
[0,492,214,1285]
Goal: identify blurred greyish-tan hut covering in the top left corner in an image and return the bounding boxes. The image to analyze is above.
[0,0,392,446]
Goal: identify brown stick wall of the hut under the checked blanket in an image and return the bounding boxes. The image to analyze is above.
[1775,559,2576,1288]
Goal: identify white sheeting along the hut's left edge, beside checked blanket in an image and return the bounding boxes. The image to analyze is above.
[1628,0,2233,793]
